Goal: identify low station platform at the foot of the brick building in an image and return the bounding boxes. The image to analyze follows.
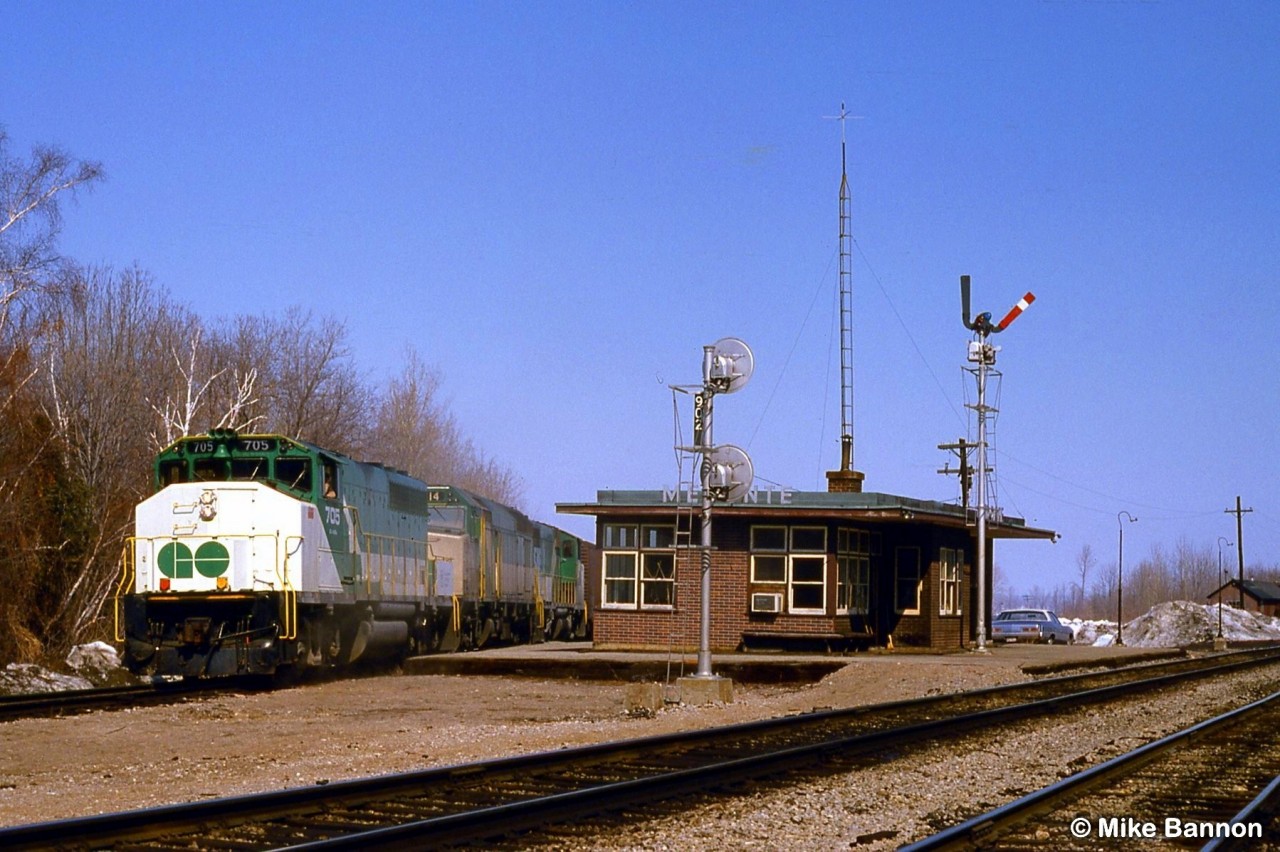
[402,642,1187,683]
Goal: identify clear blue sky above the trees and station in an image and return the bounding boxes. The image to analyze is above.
[0,0,1280,591]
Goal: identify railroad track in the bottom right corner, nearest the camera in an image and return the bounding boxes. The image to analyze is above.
[905,692,1280,852]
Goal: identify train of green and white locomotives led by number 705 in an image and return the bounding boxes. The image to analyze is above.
[115,430,588,677]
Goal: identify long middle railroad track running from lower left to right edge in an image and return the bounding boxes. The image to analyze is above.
[10,650,1280,849]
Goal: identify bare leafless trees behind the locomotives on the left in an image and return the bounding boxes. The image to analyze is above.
[0,128,524,665]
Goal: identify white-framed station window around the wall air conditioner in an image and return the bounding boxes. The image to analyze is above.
[751,526,827,614]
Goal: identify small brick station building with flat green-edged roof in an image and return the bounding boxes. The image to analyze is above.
[557,477,1055,652]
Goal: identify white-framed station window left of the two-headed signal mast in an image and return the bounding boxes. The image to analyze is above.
[600,523,676,609]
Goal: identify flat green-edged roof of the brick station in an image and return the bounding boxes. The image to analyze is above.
[556,489,1057,541]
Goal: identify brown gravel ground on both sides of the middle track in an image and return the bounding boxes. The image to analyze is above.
[0,649,1274,849]
